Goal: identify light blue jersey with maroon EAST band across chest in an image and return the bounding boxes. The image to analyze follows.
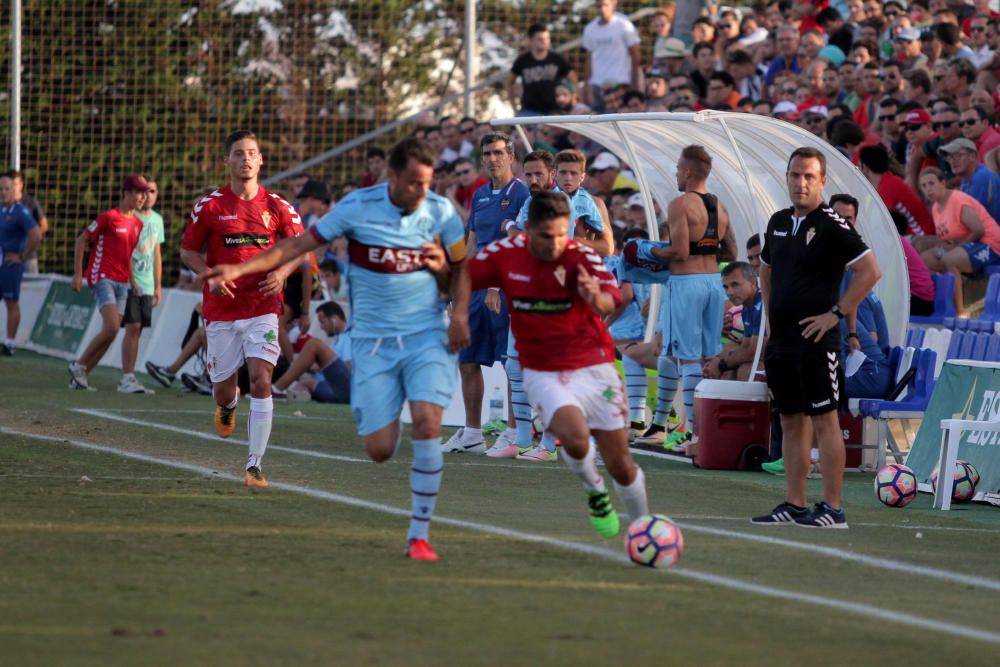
[309,183,465,339]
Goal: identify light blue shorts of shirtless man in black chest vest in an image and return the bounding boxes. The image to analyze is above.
[660,273,726,361]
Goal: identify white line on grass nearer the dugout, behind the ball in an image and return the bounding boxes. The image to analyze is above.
[80,408,1000,580]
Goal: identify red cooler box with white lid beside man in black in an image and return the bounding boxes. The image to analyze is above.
[694,380,771,470]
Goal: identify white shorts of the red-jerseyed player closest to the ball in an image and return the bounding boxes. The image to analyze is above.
[524,364,628,431]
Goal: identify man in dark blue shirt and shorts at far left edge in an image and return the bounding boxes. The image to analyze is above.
[0,174,42,357]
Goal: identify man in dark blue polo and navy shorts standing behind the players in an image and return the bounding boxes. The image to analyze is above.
[443,132,529,458]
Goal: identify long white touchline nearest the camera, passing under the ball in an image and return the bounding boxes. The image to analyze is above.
[0,427,1000,644]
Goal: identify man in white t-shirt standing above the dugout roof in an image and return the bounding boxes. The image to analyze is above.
[581,0,642,113]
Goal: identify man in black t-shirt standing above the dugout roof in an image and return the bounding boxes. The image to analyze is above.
[504,23,576,116]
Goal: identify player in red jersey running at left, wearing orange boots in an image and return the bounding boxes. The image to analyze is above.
[181,130,302,488]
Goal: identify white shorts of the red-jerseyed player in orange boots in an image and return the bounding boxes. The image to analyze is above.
[205,313,281,383]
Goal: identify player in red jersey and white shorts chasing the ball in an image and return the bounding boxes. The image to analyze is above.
[468,192,648,537]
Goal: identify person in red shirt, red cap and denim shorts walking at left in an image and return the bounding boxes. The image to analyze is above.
[68,174,149,389]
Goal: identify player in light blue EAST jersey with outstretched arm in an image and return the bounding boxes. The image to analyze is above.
[204,138,469,560]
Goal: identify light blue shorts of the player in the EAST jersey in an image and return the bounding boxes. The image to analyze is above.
[351,330,458,435]
